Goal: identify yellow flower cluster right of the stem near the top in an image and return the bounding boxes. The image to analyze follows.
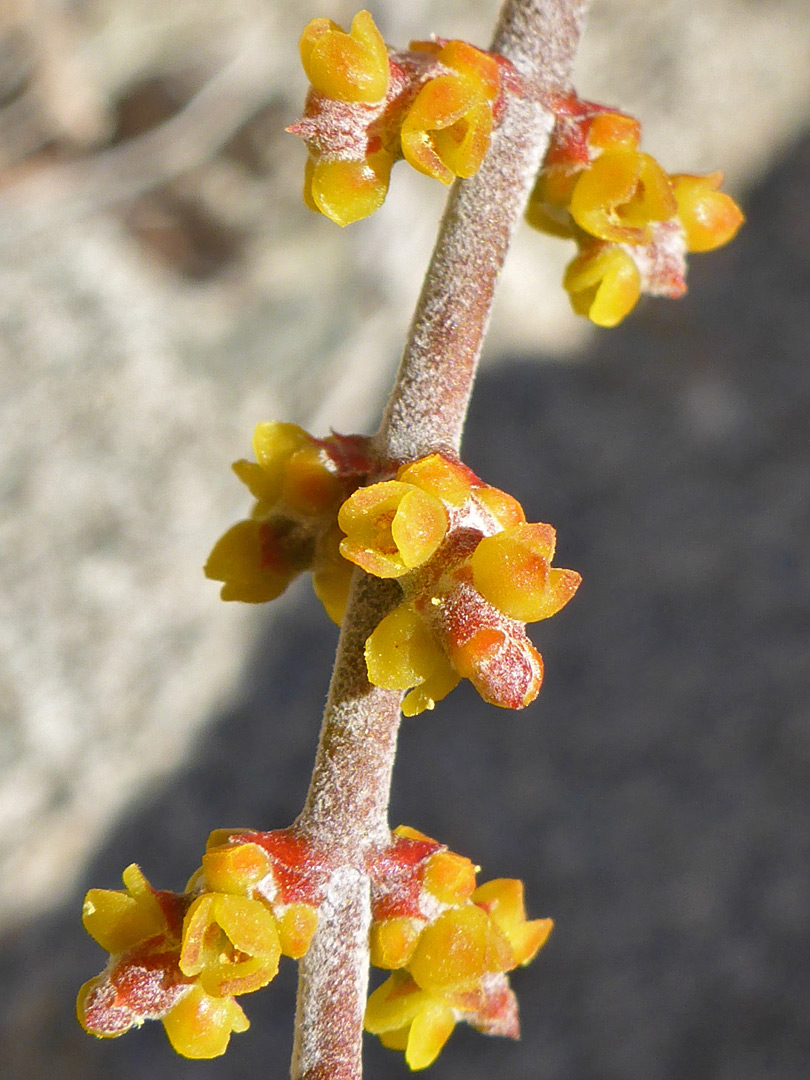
[526,96,743,326]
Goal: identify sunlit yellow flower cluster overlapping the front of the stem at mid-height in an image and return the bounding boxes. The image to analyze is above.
[338,454,580,716]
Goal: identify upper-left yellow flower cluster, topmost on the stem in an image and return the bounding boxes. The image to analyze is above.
[287,11,515,226]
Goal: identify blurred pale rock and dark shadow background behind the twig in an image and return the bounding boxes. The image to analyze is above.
[0,0,810,1080]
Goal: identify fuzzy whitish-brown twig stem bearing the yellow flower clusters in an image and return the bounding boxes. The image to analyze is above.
[292,0,588,1080]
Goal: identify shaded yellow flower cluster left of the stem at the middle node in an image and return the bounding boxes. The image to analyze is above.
[205,423,368,623]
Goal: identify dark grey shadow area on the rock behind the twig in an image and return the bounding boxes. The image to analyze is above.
[0,132,810,1080]
